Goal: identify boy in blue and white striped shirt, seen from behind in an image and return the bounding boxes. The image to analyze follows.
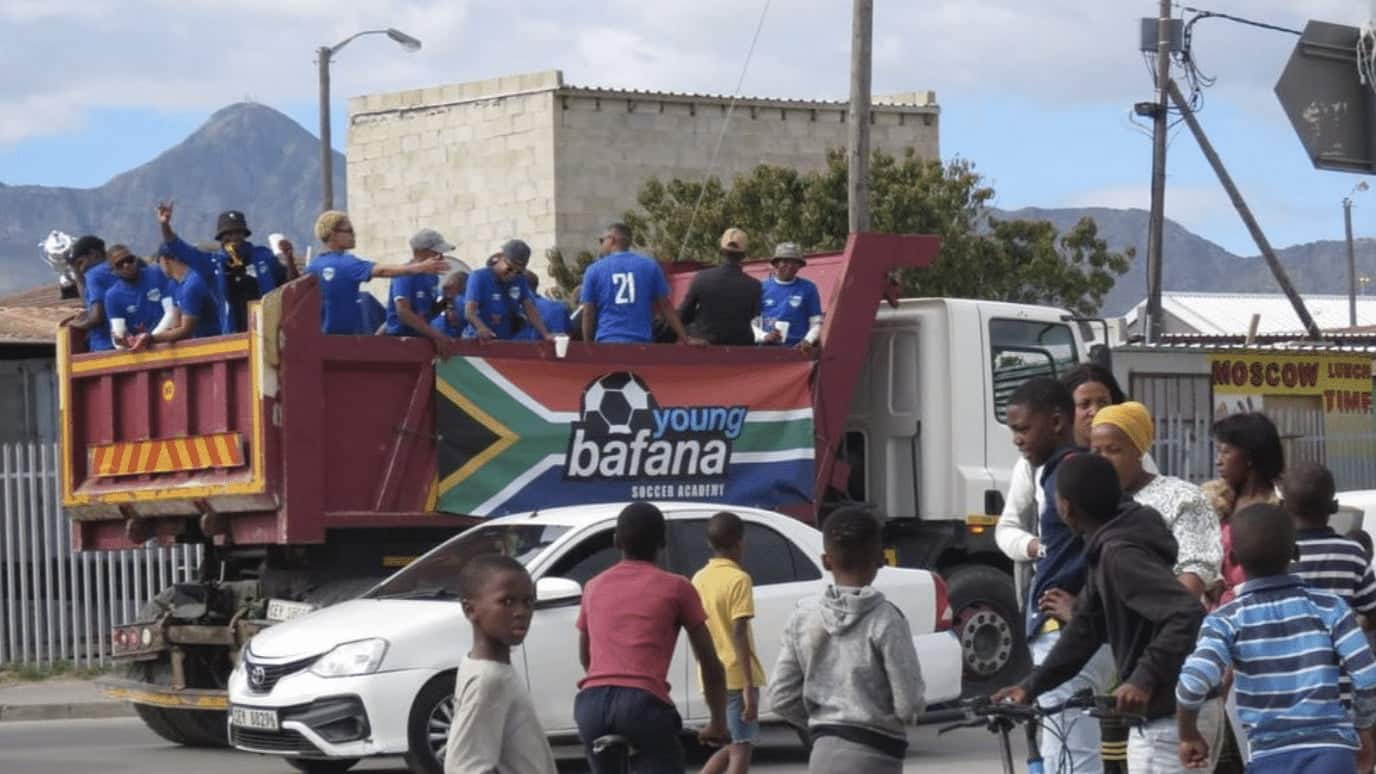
[1175,504,1376,774]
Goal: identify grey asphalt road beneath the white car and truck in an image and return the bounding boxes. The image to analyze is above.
[0,718,1022,774]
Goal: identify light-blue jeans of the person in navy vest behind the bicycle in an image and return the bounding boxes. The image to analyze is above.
[1029,631,1113,774]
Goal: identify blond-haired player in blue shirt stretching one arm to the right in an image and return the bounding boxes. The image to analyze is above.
[305,209,449,335]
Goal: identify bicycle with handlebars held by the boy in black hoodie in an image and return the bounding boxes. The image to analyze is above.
[937,693,1146,774]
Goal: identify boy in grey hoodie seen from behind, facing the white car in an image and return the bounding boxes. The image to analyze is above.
[769,508,925,774]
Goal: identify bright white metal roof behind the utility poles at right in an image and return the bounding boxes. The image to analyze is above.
[1124,293,1376,335]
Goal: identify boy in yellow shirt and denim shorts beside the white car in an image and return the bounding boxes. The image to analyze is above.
[692,511,765,774]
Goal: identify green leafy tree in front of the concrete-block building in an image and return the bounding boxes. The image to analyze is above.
[556,149,1134,314]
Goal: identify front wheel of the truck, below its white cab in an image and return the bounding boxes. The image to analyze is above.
[947,565,1032,695]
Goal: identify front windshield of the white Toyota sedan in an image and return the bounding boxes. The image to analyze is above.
[366,525,568,599]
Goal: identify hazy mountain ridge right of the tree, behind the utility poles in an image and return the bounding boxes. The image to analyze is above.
[992,207,1376,317]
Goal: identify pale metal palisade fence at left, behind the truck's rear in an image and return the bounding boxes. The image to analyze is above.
[0,443,201,668]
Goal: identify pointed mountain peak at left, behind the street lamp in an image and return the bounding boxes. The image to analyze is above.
[0,102,345,292]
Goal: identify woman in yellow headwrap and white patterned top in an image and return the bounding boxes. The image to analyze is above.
[1090,401,1223,596]
